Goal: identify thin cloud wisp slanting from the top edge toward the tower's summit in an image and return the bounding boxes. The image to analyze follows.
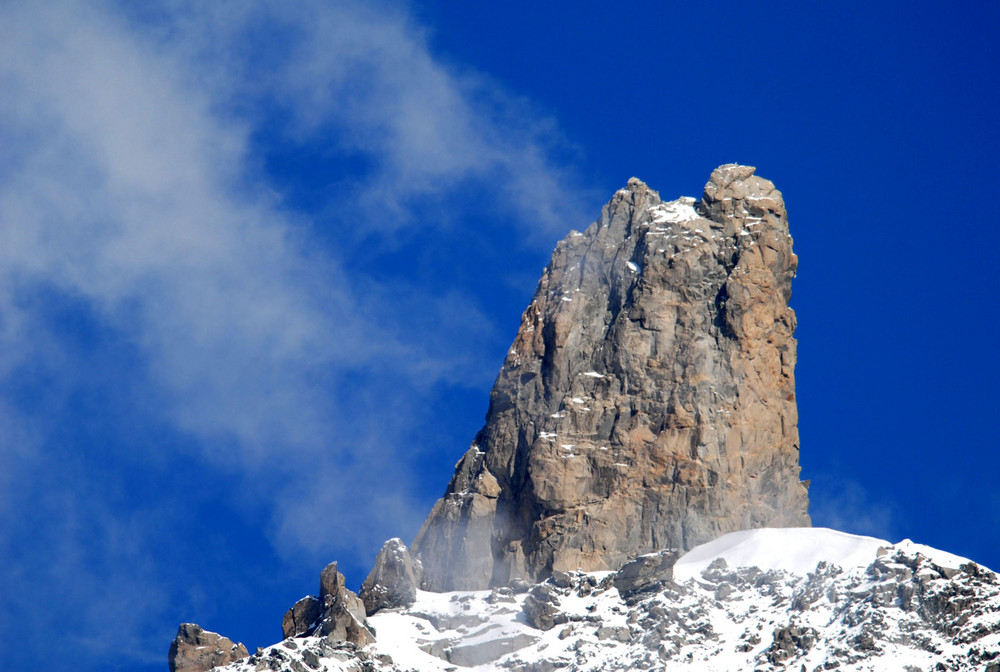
[145,2,591,239]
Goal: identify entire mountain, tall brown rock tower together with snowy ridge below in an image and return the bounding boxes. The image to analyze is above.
[169,164,1000,672]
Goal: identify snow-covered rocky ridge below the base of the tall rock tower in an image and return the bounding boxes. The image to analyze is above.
[224,528,1000,672]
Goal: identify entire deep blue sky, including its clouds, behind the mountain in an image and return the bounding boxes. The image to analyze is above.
[0,1,1000,671]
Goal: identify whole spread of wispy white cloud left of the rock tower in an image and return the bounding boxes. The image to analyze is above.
[0,2,579,668]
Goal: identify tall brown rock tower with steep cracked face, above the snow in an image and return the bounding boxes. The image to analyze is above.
[412,165,809,591]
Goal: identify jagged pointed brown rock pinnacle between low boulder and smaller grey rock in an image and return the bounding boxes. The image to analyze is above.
[281,562,375,647]
